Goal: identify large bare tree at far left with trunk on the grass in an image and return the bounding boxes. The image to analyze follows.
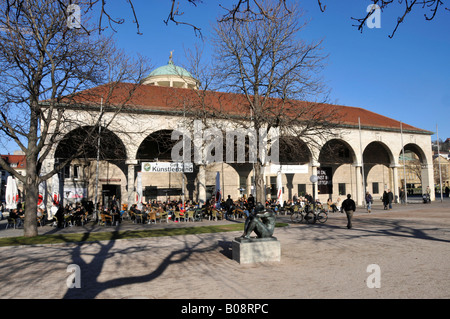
[0,0,149,237]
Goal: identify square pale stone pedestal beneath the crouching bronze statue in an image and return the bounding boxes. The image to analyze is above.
[232,237,281,264]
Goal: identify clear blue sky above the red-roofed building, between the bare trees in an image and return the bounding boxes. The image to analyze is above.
[102,0,450,140]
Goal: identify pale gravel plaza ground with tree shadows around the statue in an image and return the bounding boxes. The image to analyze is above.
[0,198,450,300]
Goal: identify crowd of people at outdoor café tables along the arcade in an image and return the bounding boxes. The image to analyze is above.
[0,188,449,228]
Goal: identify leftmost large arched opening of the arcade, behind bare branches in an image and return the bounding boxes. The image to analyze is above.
[53,126,127,207]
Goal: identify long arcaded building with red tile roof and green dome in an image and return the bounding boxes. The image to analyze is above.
[40,60,434,209]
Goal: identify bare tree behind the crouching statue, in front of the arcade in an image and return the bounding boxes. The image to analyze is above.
[183,1,338,202]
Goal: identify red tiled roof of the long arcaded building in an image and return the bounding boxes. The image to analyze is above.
[59,83,433,135]
